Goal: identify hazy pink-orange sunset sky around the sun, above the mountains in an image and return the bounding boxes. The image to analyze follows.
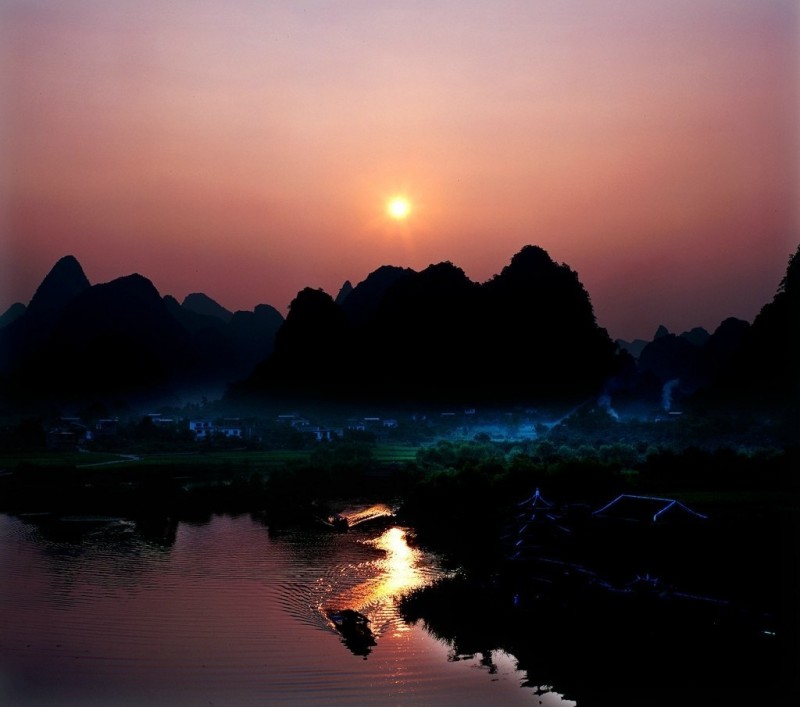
[0,0,800,338]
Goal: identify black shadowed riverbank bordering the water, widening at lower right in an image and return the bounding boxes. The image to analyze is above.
[0,443,800,706]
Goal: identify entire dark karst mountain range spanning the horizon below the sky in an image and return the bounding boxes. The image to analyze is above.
[0,246,800,404]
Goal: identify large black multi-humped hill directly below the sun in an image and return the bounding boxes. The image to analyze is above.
[236,247,620,403]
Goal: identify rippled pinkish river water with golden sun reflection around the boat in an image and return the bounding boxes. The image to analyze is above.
[0,515,575,707]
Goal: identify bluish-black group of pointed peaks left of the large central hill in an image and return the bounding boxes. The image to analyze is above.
[0,256,283,400]
